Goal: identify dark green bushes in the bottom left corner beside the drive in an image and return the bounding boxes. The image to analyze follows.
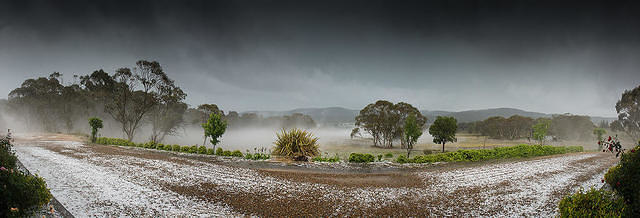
[0,135,52,217]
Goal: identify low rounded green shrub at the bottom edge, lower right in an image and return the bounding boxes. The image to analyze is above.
[558,188,625,217]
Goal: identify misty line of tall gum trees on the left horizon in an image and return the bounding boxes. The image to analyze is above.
[0,60,316,142]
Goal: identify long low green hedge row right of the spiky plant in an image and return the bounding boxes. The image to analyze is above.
[396,144,583,163]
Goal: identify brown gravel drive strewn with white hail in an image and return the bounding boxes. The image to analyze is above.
[15,135,617,217]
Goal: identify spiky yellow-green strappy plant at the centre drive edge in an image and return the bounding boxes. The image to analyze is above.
[273,128,320,160]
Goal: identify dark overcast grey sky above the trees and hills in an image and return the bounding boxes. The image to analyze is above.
[0,0,640,116]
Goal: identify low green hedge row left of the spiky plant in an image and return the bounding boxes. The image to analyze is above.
[96,137,271,160]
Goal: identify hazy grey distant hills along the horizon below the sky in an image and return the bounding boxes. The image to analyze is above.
[243,107,617,125]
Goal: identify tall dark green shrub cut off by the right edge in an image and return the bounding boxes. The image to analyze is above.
[605,146,640,217]
